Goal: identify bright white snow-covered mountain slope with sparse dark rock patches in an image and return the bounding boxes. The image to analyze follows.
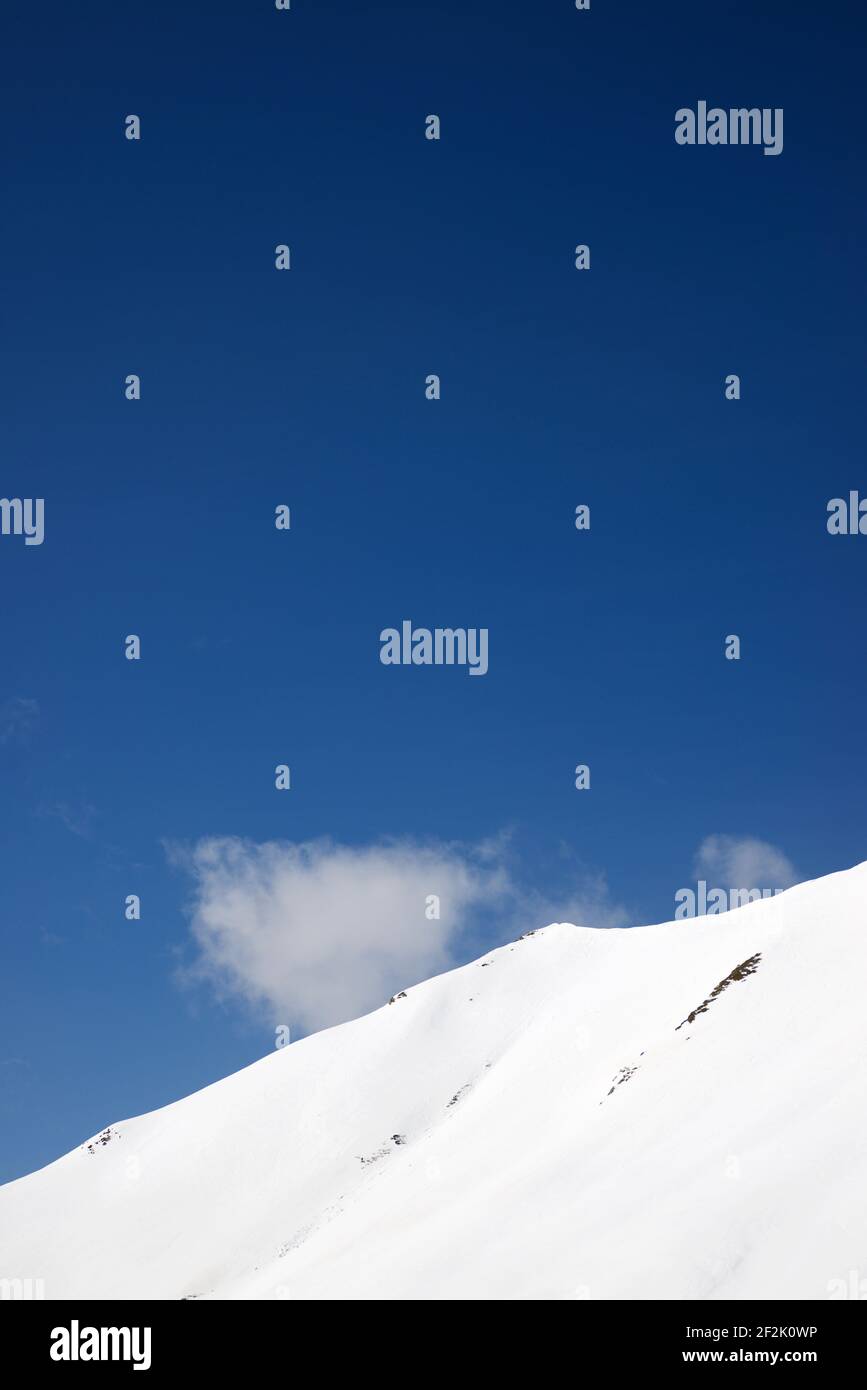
[0,863,867,1300]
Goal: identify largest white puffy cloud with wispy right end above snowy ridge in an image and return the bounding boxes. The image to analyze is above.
[167,838,628,1033]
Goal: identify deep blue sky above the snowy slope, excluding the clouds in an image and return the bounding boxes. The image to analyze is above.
[0,0,867,1180]
